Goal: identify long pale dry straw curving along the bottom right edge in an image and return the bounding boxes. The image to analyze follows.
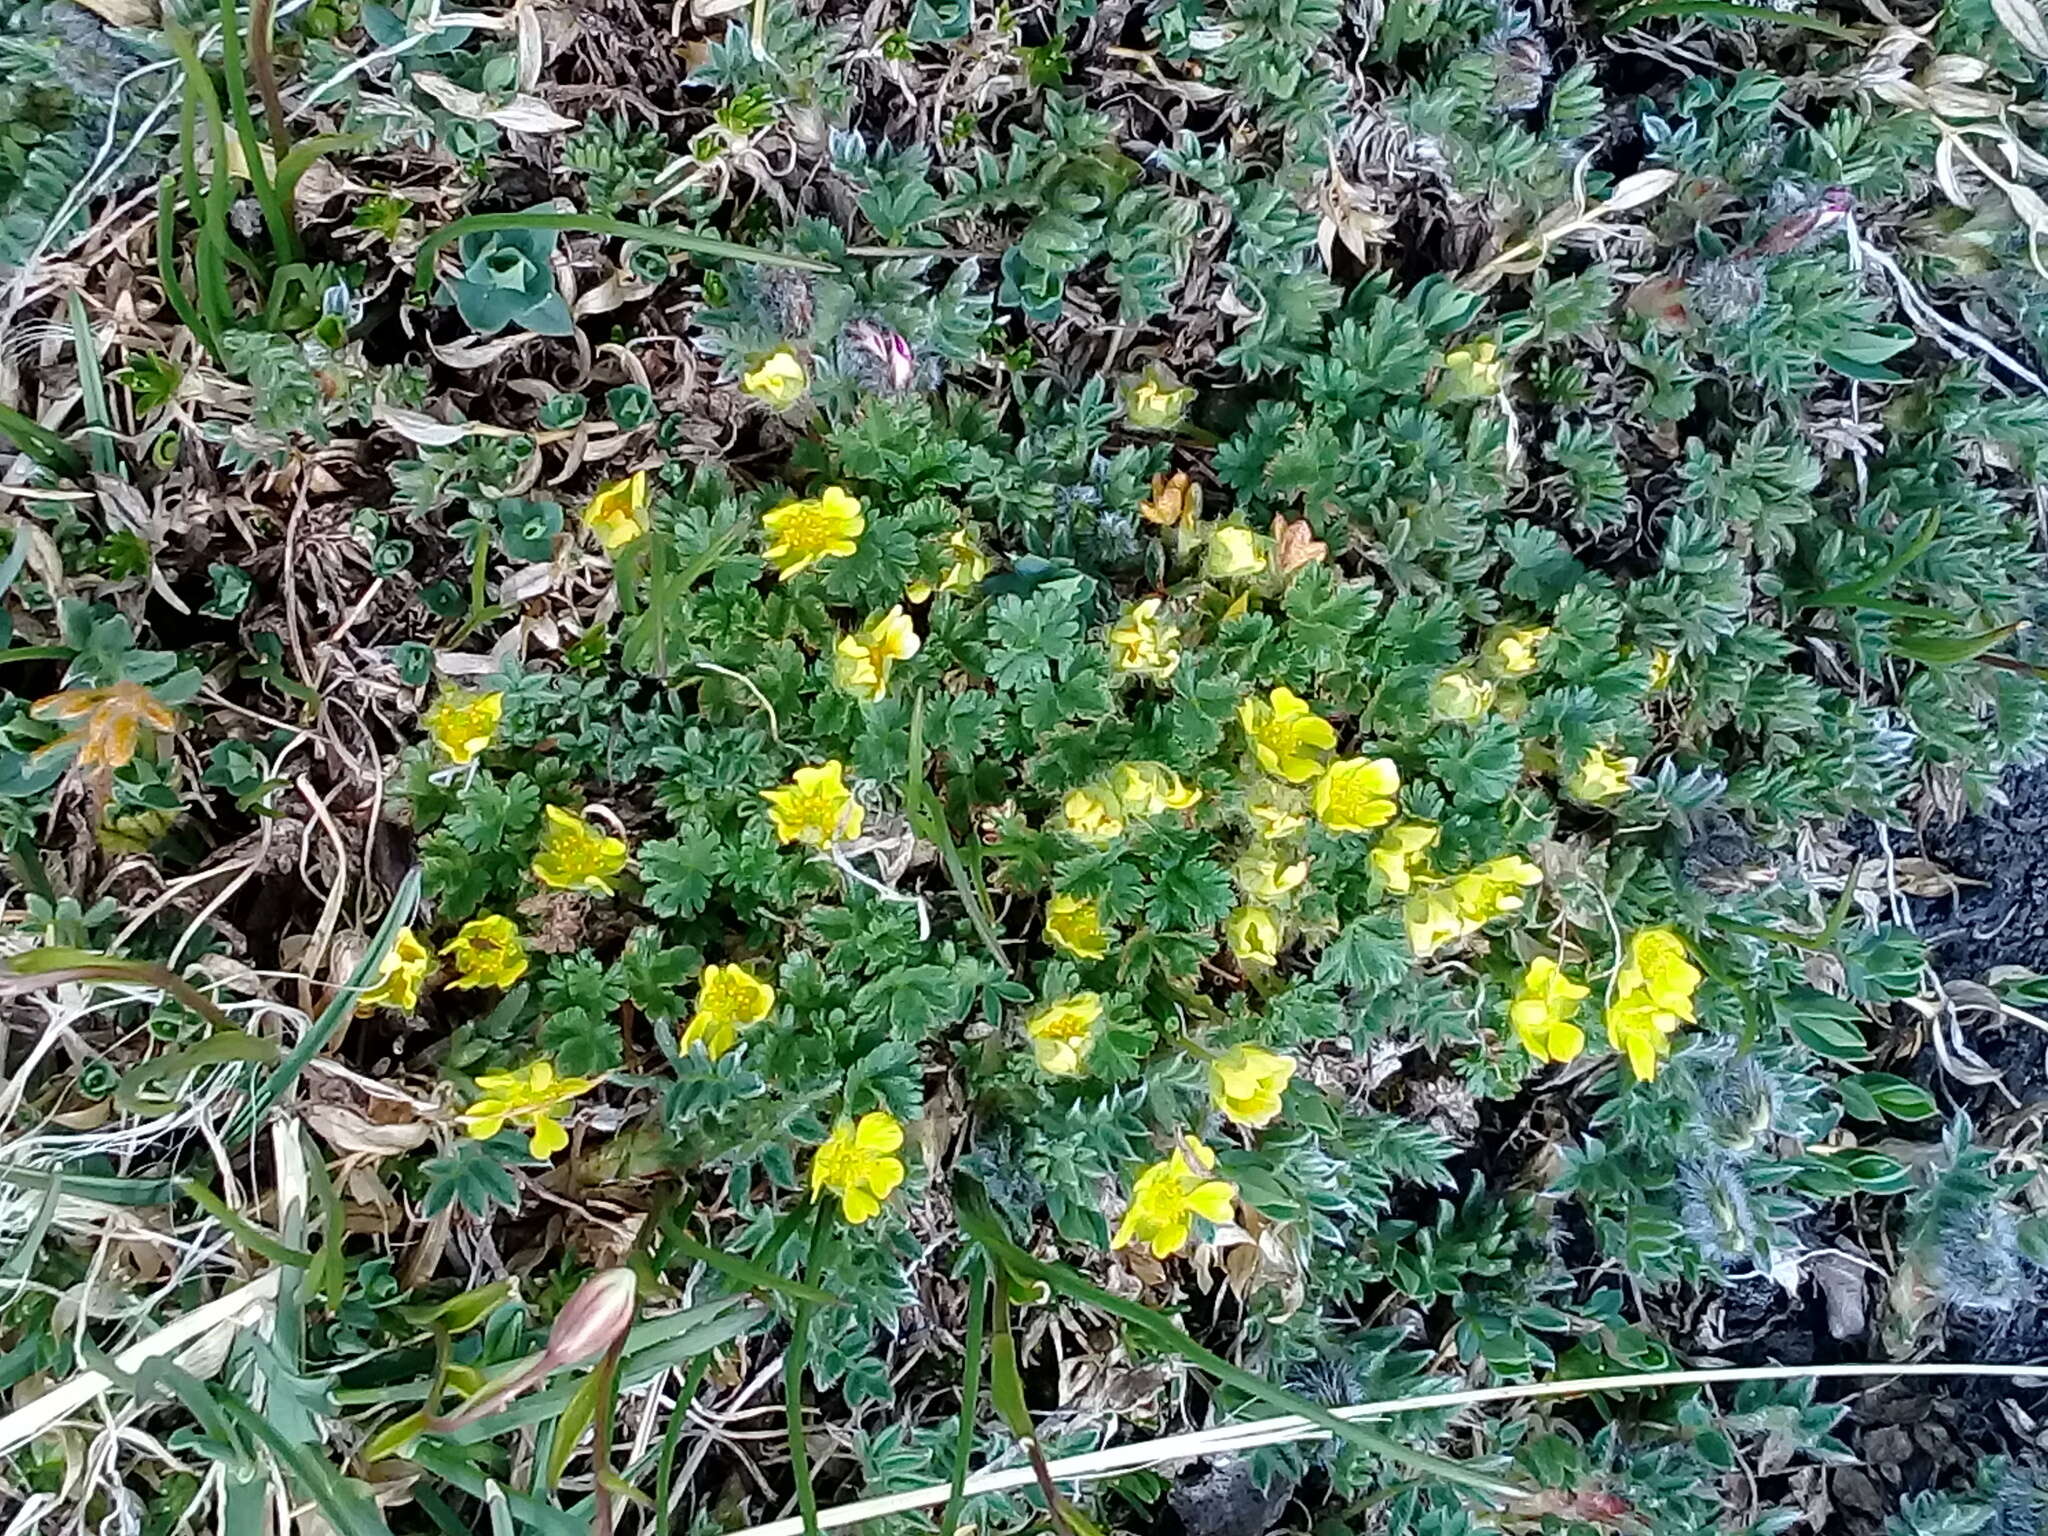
[739,1364,2048,1536]
